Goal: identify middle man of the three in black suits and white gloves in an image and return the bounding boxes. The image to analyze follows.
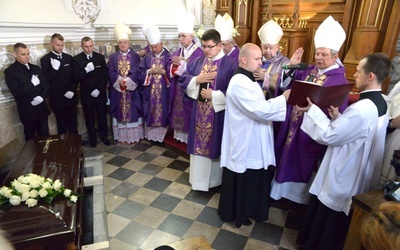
[40,33,78,134]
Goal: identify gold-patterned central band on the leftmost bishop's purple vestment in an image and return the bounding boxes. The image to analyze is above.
[118,53,132,122]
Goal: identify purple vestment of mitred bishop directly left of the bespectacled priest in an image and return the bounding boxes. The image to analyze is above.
[168,43,204,133]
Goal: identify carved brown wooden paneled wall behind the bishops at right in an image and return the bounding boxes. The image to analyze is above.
[216,0,400,92]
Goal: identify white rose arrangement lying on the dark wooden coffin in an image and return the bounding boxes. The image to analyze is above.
[0,173,78,207]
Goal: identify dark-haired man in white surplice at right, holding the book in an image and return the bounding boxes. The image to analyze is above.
[292,53,390,249]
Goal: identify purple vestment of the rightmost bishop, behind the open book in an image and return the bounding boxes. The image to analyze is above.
[274,65,347,183]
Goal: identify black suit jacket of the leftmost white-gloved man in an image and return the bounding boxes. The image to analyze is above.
[4,61,50,122]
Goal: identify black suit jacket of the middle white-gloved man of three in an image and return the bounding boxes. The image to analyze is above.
[40,52,78,109]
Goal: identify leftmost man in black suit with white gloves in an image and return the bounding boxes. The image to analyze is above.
[4,43,50,141]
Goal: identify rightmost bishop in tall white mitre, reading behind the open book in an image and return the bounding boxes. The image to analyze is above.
[271,16,347,204]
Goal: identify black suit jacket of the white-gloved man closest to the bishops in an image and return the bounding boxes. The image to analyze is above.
[73,52,108,106]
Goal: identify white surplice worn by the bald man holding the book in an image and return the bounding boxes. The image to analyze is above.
[221,74,286,173]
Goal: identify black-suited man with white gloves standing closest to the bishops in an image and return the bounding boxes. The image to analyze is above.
[73,36,110,147]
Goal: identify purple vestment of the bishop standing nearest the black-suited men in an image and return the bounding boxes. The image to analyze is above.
[107,50,142,122]
